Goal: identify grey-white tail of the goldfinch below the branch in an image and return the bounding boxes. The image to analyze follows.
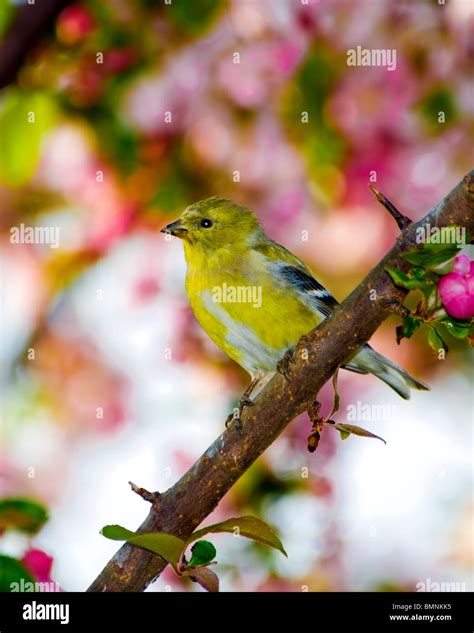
[345,345,429,400]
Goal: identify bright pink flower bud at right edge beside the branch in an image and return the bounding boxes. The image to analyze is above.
[438,255,474,319]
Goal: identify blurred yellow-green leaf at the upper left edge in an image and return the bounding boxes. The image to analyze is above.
[0,89,57,186]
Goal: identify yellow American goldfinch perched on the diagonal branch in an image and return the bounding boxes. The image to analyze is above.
[162,198,428,403]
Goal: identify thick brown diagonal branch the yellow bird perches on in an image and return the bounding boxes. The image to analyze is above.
[88,171,474,591]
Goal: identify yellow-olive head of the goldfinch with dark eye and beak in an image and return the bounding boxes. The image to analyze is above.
[161,198,262,251]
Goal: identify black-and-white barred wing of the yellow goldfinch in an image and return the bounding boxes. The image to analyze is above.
[255,240,339,319]
